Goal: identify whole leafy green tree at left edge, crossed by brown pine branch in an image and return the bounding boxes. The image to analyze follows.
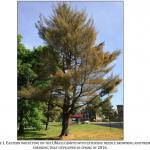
[17,35,44,133]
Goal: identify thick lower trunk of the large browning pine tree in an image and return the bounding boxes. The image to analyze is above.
[60,111,70,136]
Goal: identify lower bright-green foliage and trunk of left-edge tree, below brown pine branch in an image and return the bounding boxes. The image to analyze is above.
[17,98,44,134]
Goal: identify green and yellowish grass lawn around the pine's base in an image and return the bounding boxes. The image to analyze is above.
[18,123,123,140]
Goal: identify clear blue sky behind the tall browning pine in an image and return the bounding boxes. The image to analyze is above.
[17,1,124,106]
